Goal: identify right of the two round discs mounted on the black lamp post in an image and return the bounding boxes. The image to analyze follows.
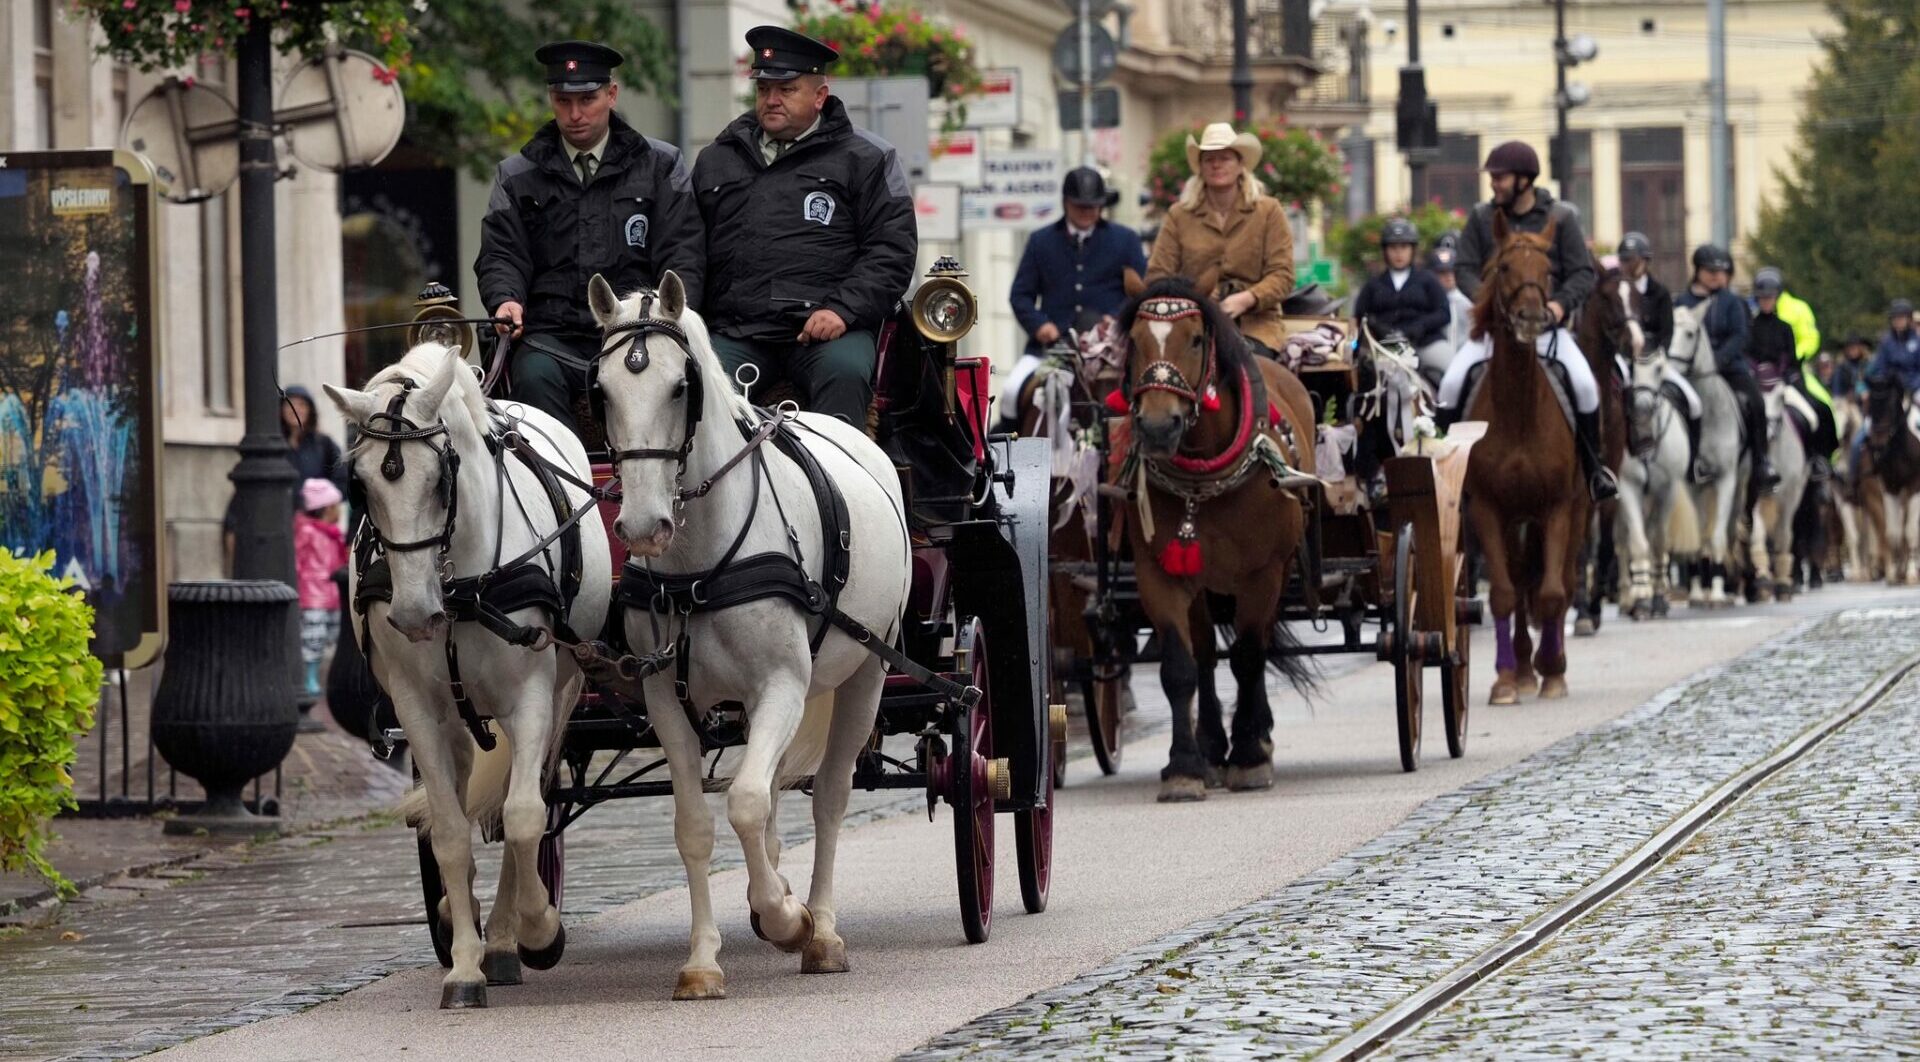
[273,48,407,173]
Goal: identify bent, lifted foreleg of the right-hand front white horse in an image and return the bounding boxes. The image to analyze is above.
[726,675,812,951]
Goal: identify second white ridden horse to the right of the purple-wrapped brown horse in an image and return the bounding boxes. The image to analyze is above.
[1667,307,1747,607]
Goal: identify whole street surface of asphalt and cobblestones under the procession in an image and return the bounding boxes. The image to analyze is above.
[0,586,1920,1062]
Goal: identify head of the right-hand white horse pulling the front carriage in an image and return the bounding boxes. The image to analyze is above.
[588,269,749,557]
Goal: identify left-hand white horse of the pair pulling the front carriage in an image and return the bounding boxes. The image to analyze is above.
[326,344,612,1006]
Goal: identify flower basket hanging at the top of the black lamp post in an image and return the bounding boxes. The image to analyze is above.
[69,0,412,71]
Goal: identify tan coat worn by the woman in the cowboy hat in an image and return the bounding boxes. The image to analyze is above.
[1146,196,1294,350]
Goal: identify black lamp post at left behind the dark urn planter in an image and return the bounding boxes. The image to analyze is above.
[228,19,300,586]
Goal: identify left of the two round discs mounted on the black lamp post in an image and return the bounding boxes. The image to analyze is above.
[121,77,240,204]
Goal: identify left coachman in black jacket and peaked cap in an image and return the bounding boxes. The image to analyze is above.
[474,40,707,424]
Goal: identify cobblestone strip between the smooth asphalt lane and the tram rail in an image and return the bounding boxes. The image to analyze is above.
[912,609,1920,1058]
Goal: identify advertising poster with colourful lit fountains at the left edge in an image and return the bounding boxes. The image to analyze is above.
[0,150,165,666]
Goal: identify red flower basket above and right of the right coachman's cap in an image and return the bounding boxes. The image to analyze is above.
[775,0,981,133]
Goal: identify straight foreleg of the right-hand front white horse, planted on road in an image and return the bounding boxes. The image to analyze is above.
[647,678,726,1001]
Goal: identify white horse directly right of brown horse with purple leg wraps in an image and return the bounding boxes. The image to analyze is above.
[1617,350,1688,620]
